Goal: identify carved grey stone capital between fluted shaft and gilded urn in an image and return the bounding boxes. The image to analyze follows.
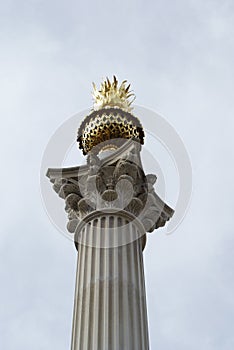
[47,140,174,238]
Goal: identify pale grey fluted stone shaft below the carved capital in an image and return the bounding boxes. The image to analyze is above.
[71,214,149,350]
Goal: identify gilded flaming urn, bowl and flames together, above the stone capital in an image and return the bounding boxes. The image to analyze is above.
[77,76,144,154]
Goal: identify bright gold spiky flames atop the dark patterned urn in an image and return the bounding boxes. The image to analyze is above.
[93,75,135,112]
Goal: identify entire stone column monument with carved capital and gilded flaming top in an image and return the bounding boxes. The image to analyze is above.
[47,77,173,350]
